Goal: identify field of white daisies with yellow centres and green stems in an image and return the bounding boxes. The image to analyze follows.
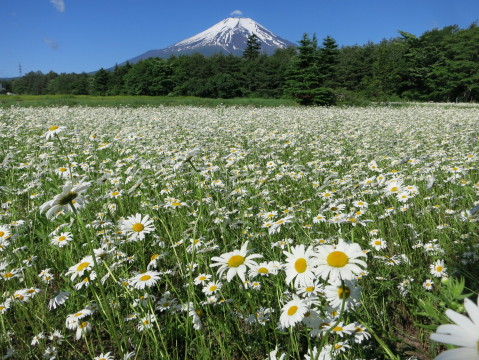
[0,105,479,360]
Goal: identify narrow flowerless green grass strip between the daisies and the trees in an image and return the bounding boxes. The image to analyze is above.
[0,95,296,107]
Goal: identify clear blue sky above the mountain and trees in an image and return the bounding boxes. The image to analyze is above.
[0,0,479,78]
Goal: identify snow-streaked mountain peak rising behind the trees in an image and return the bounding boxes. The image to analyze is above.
[123,17,296,63]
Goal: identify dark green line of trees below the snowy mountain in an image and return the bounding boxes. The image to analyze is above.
[4,23,479,105]
